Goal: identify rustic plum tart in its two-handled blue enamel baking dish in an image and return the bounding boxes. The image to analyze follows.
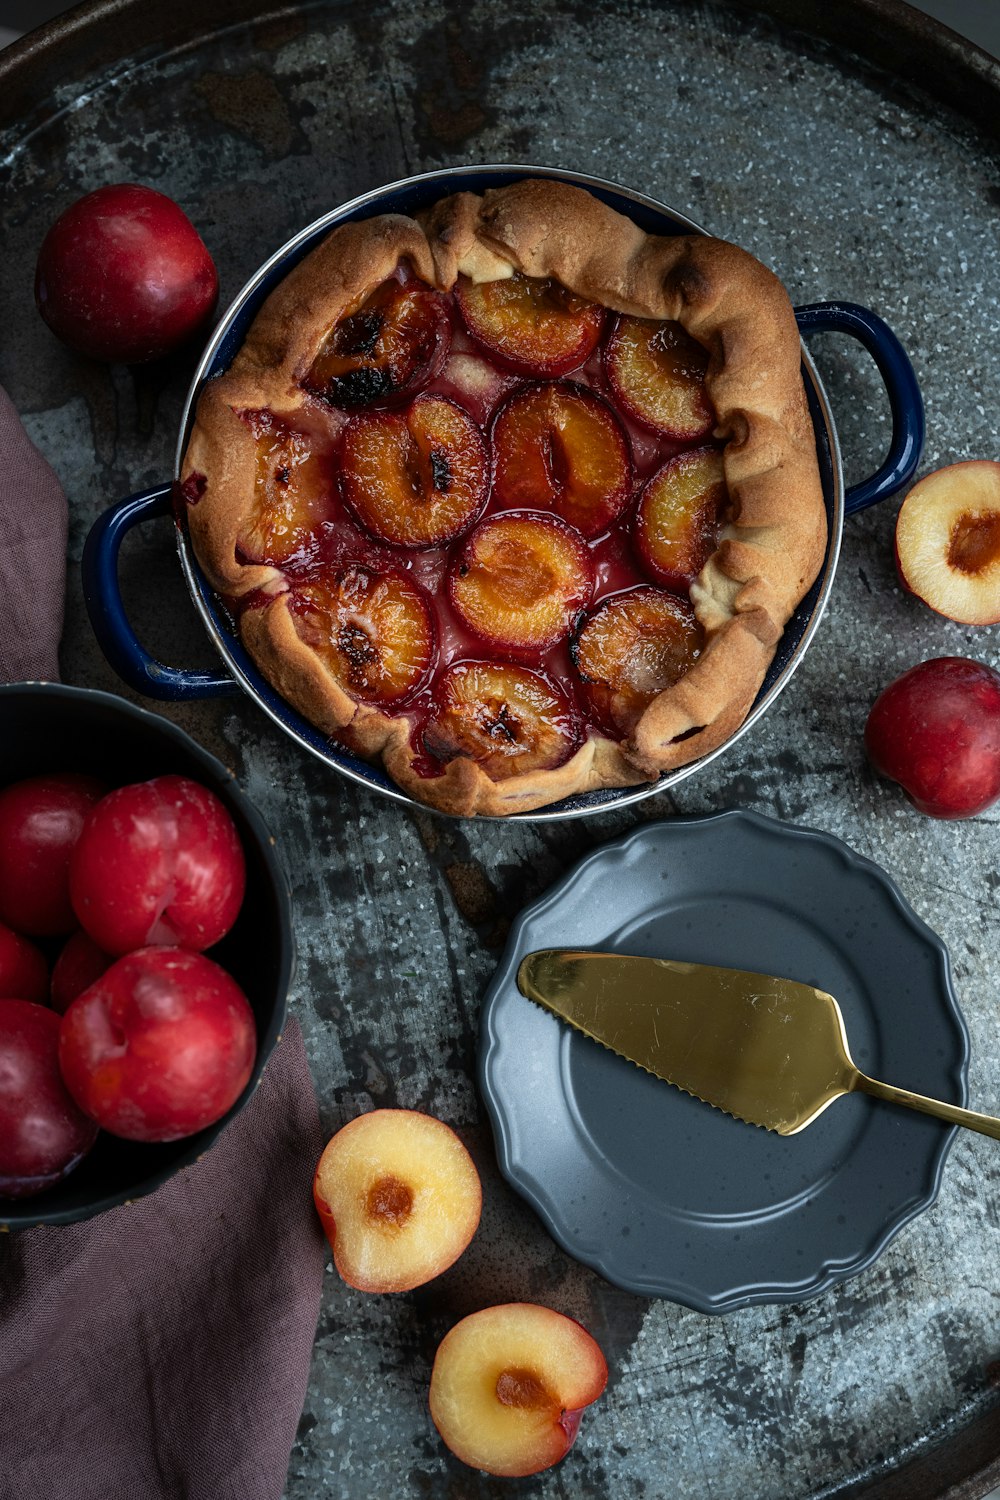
[84,167,924,819]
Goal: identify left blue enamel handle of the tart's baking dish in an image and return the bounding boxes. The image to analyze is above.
[82,485,240,701]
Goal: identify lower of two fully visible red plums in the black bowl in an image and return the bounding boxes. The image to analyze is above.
[58,948,256,1140]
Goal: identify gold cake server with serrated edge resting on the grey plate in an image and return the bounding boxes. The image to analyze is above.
[517,948,1000,1140]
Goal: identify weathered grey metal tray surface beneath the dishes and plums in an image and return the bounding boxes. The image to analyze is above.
[0,0,1000,1500]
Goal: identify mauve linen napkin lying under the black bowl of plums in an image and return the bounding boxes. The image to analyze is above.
[0,390,324,1500]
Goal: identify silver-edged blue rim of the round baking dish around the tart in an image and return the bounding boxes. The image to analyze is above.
[167,162,844,822]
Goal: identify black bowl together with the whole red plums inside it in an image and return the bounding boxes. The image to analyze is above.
[0,683,294,1230]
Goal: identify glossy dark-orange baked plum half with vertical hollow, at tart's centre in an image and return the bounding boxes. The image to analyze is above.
[493,381,633,537]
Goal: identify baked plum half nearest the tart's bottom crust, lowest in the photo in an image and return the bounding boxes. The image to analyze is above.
[424,662,582,782]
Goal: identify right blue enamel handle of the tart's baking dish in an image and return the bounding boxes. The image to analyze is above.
[795,302,924,516]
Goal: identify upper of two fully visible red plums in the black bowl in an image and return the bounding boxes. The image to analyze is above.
[69,776,246,954]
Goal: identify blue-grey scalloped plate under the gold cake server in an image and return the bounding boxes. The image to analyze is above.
[480,812,969,1313]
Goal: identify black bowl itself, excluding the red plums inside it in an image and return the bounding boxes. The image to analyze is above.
[0,683,294,1230]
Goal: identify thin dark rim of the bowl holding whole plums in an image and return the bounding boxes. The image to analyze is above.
[0,680,295,1233]
